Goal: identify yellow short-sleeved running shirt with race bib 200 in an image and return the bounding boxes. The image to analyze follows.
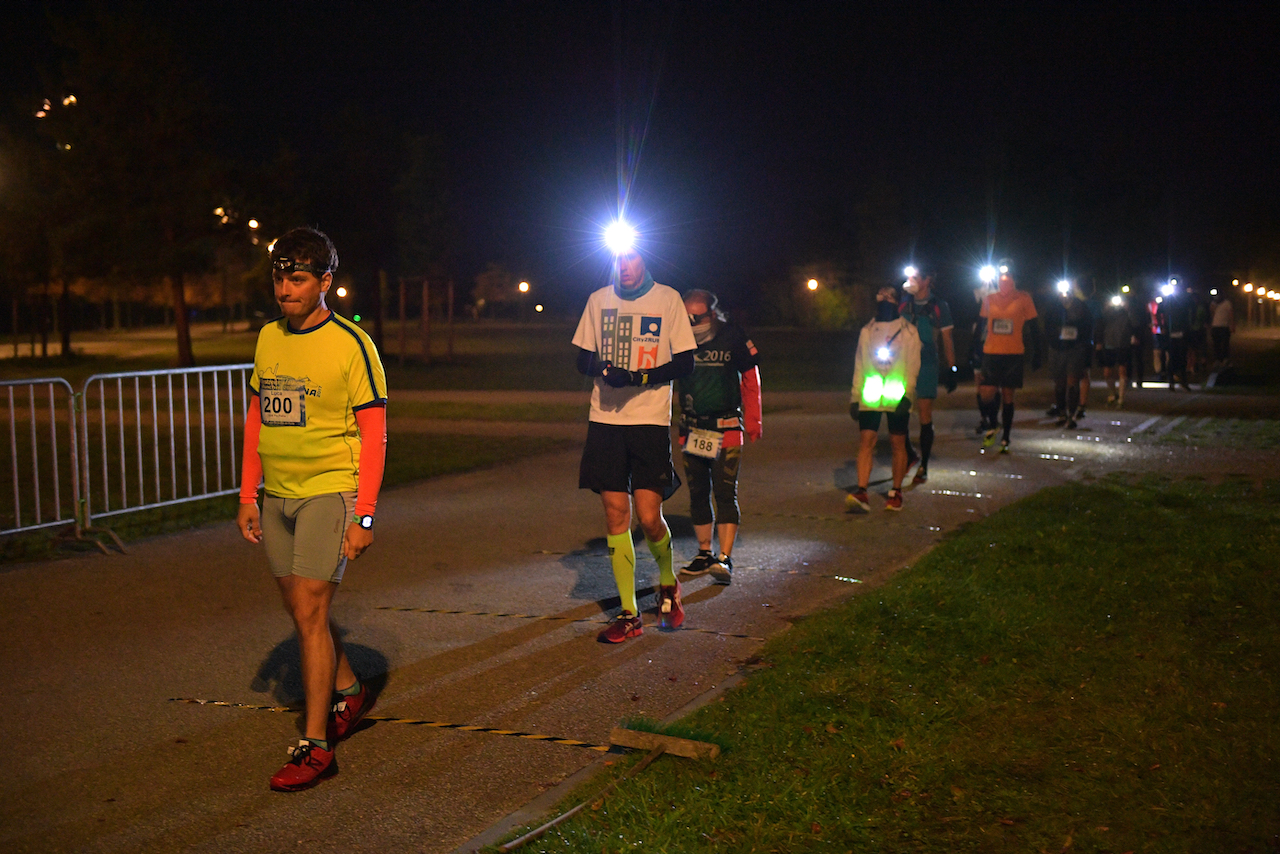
[250,314,387,498]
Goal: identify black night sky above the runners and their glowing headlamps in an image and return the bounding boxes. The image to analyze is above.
[0,0,1280,311]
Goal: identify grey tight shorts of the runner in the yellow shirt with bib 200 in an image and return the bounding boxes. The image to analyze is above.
[262,492,356,584]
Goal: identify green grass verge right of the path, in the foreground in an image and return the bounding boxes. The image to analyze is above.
[499,478,1280,854]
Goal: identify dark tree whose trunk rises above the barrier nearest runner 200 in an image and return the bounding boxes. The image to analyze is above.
[47,6,219,366]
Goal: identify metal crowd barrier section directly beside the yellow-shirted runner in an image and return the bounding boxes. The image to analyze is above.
[79,362,253,529]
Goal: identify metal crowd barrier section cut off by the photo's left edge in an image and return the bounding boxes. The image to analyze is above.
[0,378,81,535]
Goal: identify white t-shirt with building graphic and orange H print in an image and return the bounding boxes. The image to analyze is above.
[573,283,698,426]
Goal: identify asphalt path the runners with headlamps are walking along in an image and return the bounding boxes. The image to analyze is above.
[0,387,1280,853]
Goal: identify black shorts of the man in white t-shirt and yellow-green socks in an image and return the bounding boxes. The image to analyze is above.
[577,421,678,498]
